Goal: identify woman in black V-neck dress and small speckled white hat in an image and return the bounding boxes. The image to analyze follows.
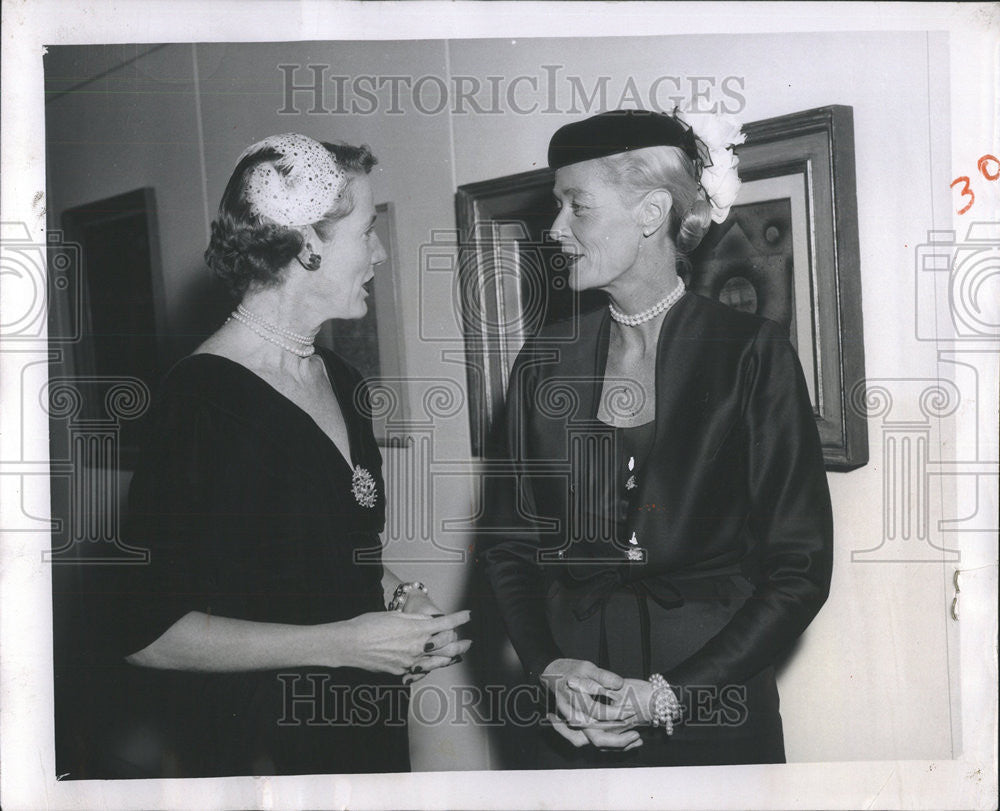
[94,134,469,777]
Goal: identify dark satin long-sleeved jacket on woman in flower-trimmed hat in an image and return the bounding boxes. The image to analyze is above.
[482,293,833,688]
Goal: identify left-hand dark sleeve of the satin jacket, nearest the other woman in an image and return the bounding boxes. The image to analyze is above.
[482,350,562,680]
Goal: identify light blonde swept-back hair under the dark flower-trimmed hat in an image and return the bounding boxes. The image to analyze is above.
[598,146,712,259]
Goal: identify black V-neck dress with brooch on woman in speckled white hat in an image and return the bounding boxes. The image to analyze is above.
[60,351,409,778]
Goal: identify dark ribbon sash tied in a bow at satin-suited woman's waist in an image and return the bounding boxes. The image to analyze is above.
[573,564,753,678]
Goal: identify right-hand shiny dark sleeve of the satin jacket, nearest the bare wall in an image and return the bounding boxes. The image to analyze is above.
[664,322,833,687]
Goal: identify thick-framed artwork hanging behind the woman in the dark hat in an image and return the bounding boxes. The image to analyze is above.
[456,105,868,471]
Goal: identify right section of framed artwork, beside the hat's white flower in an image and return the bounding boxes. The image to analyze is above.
[686,106,868,470]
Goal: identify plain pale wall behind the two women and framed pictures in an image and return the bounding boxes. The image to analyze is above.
[46,33,952,769]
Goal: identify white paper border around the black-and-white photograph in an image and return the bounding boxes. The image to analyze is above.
[0,0,1000,809]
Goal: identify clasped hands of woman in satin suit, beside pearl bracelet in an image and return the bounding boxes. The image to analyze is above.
[541,659,653,752]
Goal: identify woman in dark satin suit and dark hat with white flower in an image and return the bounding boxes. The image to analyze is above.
[483,111,833,768]
